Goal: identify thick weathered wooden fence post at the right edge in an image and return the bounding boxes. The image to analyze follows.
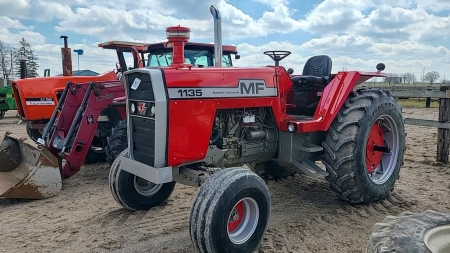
[437,86,450,163]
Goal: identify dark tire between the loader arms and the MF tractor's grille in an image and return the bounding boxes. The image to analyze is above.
[106,120,128,165]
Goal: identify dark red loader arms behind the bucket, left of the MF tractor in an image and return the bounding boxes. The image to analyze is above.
[41,80,125,179]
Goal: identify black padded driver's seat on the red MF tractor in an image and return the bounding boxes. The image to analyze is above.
[291,55,332,89]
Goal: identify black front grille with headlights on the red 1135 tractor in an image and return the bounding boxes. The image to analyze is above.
[127,72,155,167]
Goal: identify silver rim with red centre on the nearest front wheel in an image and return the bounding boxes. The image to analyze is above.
[227,197,259,244]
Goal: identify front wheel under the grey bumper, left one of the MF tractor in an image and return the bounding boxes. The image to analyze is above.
[109,149,176,211]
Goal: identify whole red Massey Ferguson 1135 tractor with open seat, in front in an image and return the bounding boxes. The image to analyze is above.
[109,6,405,253]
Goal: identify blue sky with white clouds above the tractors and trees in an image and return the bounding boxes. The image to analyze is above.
[0,0,450,80]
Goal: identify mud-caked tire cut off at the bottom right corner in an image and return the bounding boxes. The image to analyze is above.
[366,210,450,253]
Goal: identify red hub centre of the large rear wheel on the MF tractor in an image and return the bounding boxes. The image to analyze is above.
[366,123,385,173]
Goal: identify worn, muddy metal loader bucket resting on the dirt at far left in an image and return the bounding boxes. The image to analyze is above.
[0,133,62,199]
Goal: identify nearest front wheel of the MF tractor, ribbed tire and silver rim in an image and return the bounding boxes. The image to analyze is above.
[189,168,271,253]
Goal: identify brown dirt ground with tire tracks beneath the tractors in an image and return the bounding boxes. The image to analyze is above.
[0,108,450,252]
